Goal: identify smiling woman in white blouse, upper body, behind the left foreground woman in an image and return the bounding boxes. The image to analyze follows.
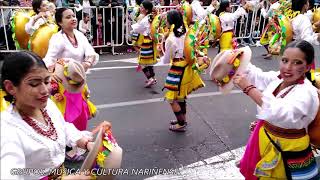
[43,8,99,72]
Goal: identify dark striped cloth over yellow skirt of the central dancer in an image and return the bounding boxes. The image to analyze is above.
[164,66,184,91]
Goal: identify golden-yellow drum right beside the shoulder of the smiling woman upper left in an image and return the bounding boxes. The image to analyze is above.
[30,24,58,58]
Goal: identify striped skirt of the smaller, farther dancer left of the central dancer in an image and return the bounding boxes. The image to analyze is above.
[138,36,157,66]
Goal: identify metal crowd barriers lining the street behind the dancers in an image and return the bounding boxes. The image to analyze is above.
[0,4,280,54]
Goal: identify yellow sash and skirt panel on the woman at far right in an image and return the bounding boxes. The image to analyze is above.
[255,127,310,180]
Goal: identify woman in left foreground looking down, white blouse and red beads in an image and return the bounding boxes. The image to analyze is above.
[1,51,92,179]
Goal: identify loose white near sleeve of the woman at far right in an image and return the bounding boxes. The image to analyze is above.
[257,82,319,129]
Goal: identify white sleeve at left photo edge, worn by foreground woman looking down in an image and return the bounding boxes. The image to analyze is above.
[0,116,25,179]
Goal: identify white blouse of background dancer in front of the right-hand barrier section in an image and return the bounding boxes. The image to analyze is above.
[219,7,247,32]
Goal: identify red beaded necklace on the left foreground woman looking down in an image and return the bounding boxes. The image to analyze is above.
[20,109,58,141]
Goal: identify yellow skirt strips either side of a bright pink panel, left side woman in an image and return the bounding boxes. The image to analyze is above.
[51,82,97,117]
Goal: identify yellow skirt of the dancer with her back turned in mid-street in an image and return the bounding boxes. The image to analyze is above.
[165,61,205,102]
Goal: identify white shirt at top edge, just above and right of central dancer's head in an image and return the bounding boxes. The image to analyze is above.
[191,0,215,22]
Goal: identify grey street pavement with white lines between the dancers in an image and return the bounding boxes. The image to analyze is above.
[67,47,319,180]
